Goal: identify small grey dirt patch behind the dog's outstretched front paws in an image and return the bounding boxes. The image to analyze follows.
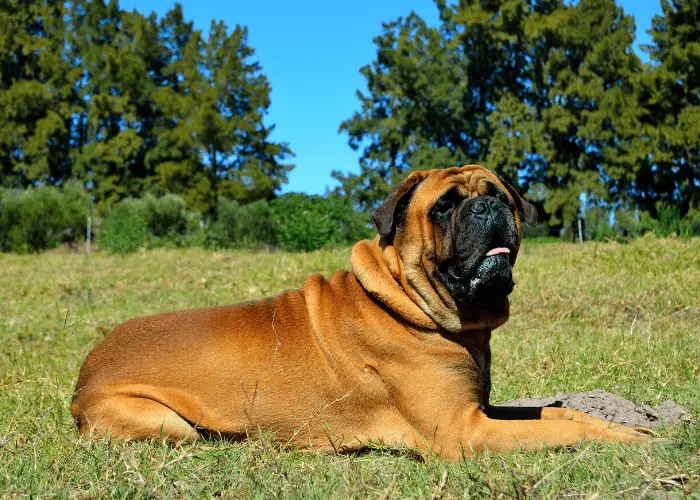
[505,389,690,428]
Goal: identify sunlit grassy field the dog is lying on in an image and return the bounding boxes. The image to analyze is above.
[0,238,700,498]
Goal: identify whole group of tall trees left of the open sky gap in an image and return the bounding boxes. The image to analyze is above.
[0,0,292,213]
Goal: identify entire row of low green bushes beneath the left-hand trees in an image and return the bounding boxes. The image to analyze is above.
[0,182,373,253]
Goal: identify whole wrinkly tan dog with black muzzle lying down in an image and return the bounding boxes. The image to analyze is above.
[72,165,645,460]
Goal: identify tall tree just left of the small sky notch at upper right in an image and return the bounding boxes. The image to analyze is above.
[531,0,643,226]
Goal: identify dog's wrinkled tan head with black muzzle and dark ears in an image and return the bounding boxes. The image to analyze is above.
[358,165,537,330]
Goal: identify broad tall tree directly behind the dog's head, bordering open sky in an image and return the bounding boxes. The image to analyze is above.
[334,0,561,217]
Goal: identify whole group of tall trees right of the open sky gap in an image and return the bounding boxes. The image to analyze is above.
[334,0,700,234]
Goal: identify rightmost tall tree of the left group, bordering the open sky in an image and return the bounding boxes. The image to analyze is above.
[148,14,292,212]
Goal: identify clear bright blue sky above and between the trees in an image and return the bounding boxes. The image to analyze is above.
[119,0,661,194]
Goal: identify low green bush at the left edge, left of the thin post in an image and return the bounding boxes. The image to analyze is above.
[0,182,90,252]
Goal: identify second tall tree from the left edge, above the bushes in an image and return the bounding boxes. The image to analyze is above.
[71,0,163,209]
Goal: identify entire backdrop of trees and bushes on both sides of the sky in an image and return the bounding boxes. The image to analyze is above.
[0,0,700,251]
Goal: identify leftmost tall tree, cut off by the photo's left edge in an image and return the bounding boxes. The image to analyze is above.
[0,0,74,187]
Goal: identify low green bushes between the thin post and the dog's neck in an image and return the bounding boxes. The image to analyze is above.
[100,194,373,253]
